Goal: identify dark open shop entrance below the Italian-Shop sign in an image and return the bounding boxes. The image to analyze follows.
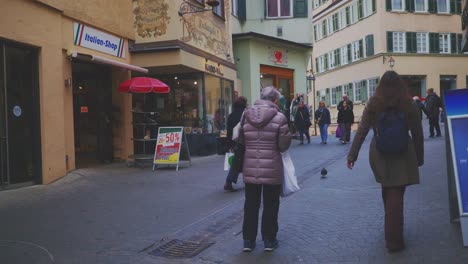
[72,62,113,168]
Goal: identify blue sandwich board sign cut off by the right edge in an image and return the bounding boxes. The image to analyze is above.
[445,89,468,246]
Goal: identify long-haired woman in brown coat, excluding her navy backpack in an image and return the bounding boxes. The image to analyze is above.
[347,71,424,252]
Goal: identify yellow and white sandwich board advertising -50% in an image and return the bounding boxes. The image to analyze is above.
[153,127,190,171]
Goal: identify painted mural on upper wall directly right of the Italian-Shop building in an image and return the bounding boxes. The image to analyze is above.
[133,0,171,38]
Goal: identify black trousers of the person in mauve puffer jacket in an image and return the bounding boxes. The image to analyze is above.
[242,183,281,240]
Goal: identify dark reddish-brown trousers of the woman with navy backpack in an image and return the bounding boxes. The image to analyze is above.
[382,186,406,249]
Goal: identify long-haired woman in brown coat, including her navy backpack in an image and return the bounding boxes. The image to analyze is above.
[347,71,424,252]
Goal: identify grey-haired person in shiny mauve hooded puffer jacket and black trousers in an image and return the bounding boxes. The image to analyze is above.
[239,86,292,252]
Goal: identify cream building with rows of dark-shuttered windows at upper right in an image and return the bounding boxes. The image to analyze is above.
[309,0,468,121]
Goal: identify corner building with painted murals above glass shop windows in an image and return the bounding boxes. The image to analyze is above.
[131,0,236,155]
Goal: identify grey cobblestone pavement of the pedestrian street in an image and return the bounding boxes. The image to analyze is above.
[0,122,468,264]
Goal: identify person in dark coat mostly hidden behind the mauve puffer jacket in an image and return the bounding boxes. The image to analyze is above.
[224,96,247,192]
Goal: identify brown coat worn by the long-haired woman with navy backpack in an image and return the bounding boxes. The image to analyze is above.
[347,98,424,187]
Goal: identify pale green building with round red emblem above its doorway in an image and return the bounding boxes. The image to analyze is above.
[230,0,312,118]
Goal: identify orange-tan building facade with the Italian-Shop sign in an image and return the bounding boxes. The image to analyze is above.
[0,0,139,188]
